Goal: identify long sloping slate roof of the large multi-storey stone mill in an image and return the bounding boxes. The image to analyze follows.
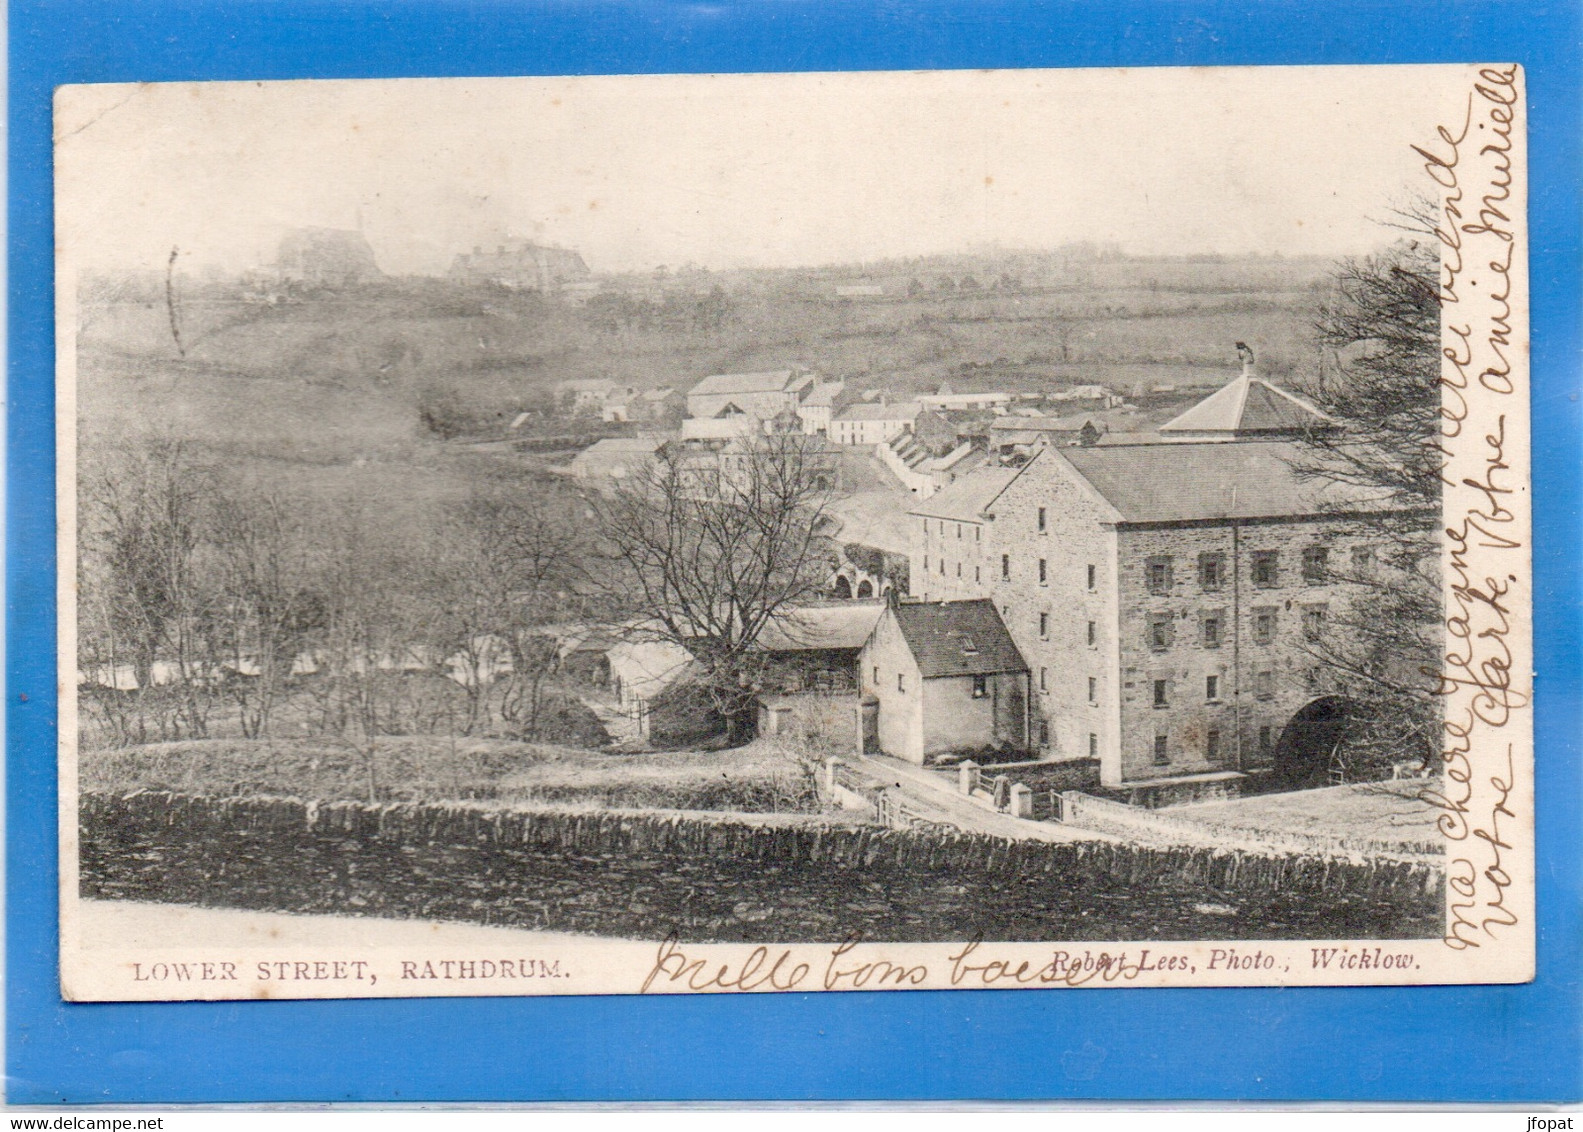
[1057,440,1346,522]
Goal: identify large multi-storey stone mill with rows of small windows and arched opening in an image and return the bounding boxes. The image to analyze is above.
[912,367,1405,801]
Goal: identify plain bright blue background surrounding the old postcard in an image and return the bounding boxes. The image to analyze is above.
[6,0,1583,1104]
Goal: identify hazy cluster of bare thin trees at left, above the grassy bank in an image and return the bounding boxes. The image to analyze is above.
[78,442,590,769]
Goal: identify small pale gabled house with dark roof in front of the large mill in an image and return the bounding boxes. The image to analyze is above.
[861,598,1031,765]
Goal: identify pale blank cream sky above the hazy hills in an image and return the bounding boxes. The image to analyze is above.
[55,66,1467,274]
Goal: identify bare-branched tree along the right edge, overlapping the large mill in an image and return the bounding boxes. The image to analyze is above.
[1298,226,1445,777]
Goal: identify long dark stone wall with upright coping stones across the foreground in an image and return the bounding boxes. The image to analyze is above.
[81,793,1442,942]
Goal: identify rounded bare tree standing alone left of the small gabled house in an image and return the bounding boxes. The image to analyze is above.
[594,434,833,739]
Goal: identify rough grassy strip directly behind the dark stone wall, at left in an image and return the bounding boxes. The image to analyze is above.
[79,736,818,814]
